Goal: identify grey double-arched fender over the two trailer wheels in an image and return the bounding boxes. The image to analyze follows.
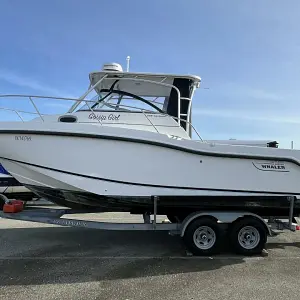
[180,211,272,237]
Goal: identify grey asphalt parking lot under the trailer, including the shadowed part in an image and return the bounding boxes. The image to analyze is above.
[0,214,300,300]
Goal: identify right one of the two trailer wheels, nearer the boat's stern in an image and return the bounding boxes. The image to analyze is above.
[229,217,267,255]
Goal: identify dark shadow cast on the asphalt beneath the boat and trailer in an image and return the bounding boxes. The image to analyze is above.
[0,227,248,286]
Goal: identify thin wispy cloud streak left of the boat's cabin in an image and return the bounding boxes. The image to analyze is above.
[0,69,76,98]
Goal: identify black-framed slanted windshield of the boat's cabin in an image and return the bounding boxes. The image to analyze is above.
[78,90,165,113]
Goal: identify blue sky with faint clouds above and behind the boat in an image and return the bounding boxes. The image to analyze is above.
[0,0,300,148]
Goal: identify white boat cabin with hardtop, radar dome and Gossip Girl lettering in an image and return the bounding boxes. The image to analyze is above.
[66,64,201,138]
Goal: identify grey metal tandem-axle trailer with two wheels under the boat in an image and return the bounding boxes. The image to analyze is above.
[0,194,300,255]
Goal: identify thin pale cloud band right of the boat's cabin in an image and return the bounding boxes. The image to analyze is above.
[193,108,300,124]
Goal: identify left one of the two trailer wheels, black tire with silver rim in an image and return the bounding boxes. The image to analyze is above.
[183,217,221,256]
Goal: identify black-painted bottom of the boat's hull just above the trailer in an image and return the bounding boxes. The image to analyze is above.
[22,186,300,217]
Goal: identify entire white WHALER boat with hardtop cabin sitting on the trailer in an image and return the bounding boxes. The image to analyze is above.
[0,64,300,215]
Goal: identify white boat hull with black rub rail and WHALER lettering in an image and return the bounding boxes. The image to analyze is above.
[0,124,300,211]
